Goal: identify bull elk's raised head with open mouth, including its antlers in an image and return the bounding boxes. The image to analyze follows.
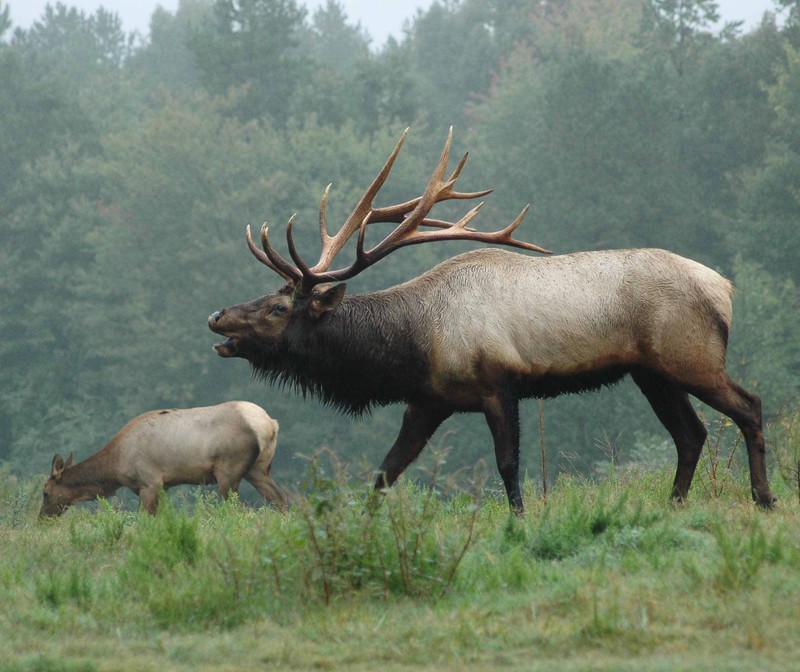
[208,128,549,356]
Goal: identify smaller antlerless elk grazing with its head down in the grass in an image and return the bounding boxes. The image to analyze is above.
[39,401,286,517]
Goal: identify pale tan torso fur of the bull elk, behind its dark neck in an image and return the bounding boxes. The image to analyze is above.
[416,249,733,402]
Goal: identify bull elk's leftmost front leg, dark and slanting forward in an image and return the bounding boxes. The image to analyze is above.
[375,403,453,490]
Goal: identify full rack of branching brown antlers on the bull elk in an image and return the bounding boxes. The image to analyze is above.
[247,127,550,289]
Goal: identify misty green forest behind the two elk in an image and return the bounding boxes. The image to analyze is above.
[0,0,800,489]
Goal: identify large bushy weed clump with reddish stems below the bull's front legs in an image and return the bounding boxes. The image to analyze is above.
[298,454,478,604]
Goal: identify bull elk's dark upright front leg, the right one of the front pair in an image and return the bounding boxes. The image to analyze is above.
[483,393,525,515]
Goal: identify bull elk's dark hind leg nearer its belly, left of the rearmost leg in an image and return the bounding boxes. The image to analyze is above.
[633,371,708,501]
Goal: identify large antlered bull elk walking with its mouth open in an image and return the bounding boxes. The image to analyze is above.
[208,129,774,513]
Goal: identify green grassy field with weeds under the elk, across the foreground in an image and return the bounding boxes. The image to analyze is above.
[0,440,800,672]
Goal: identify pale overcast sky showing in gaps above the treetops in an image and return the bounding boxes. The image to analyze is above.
[2,0,775,47]
